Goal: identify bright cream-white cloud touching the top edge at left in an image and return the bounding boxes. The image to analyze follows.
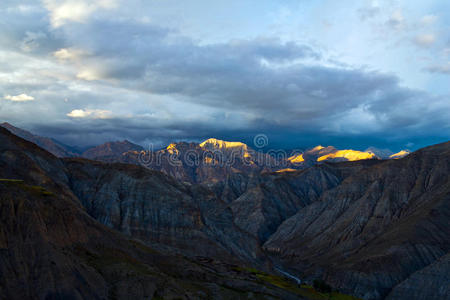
[43,0,117,27]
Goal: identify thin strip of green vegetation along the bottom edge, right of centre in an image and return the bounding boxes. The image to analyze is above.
[235,267,358,300]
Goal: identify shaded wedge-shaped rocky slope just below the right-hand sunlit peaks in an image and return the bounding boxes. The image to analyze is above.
[230,161,378,242]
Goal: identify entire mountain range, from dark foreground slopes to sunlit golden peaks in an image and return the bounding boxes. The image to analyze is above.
[0,122,450,299]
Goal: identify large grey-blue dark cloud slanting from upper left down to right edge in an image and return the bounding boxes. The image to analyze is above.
[59,21,445,133]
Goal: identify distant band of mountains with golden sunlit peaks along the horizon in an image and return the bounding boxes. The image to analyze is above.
[0,123,409,183]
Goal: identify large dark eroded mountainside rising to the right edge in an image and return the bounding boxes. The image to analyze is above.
[264,143,450,299]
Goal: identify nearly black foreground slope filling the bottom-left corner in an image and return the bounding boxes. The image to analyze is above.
[0,179,310,299]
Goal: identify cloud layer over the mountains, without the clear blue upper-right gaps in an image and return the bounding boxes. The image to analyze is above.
[0,0,450,148]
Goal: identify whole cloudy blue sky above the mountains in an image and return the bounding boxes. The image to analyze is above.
[0,0,450,151]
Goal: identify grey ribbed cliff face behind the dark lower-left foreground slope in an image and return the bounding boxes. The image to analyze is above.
[65,159,261,261]
